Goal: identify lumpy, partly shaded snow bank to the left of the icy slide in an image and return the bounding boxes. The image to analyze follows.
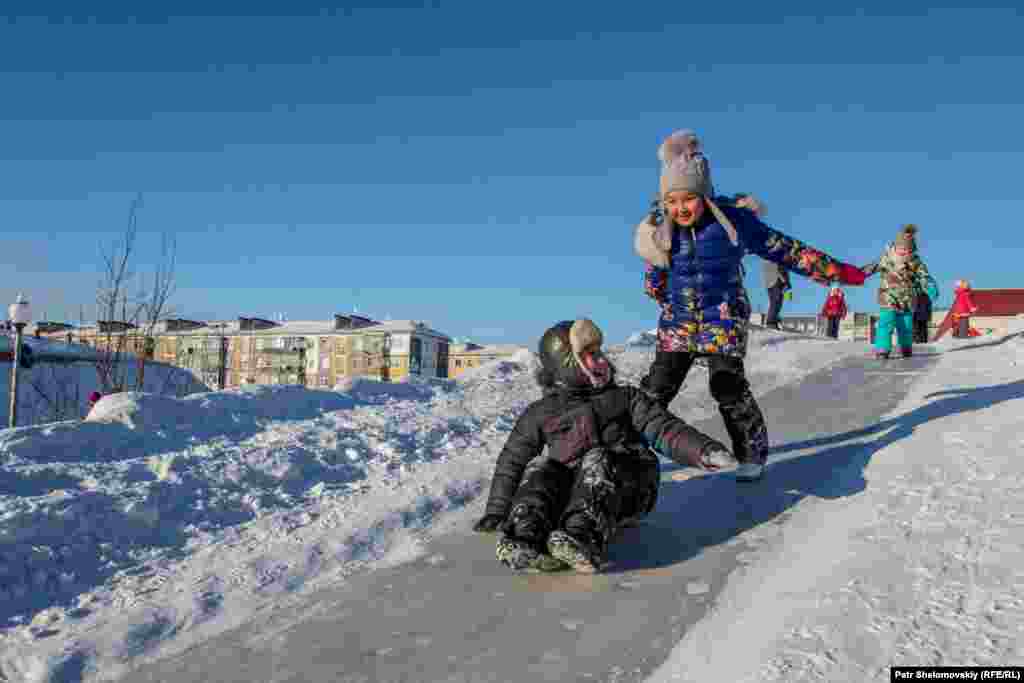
[0,333,863,681]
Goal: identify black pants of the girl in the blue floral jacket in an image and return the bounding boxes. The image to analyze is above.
[640,349,768,465]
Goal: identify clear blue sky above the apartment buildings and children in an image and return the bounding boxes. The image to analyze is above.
[0,0,1024,344]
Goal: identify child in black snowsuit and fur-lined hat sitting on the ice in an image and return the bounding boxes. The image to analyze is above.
[473,319,732,572]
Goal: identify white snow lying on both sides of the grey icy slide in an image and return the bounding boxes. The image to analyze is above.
[0,327,1024,683]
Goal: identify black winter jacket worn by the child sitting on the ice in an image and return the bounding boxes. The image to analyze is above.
[484,383,713,518]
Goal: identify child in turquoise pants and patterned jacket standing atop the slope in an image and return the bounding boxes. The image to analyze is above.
[863,223,938,358]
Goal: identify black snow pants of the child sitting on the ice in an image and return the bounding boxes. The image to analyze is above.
[502,447,660,552]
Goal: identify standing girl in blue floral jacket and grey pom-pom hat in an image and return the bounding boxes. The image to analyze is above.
[634,130,864,481]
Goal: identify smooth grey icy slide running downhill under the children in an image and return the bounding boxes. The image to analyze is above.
[119,357,936,683]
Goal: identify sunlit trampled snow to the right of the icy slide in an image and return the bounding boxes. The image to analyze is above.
[650,321,1024,683]
